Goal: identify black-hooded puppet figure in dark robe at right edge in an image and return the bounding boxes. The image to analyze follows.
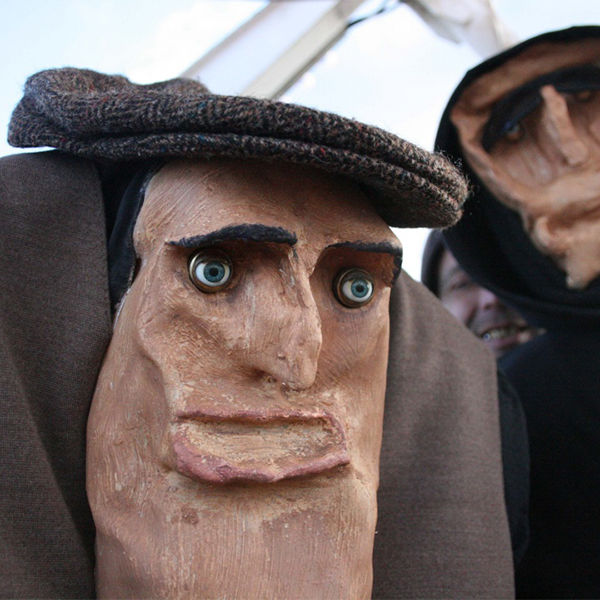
[436,27,600,599]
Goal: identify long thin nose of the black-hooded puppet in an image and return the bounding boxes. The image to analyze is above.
[540,85,589,167]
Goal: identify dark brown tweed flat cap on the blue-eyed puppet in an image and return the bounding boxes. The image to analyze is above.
[8,68,468,227]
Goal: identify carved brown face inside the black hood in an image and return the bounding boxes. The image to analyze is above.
[451,39,600,288]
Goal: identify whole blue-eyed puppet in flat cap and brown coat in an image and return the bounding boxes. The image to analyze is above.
[0,69,513,600]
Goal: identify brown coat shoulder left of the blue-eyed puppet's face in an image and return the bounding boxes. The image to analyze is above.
[0,152,111,600]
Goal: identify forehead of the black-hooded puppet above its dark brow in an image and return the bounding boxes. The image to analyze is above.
[452,38,600,116]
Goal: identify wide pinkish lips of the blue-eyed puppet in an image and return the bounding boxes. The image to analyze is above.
[173,412,350,484]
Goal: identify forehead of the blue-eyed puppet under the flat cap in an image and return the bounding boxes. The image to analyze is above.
[134,159,400,253]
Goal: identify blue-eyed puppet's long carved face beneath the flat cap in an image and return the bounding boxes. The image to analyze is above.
[88,160,400,600]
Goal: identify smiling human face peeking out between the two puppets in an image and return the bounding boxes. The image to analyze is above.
[438,250,540,359]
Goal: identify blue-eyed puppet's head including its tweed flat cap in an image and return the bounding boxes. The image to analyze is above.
[5,69,466,599]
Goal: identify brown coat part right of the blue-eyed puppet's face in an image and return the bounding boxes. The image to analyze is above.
[373,273,514,600]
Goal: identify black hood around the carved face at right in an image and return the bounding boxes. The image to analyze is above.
[435,26,600,329]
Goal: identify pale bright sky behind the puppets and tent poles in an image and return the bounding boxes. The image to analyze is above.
[0,0,600,277]
